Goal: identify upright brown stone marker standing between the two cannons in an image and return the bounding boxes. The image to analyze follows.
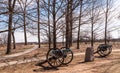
[85,47,94,62]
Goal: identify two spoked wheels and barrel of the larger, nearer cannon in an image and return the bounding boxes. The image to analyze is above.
[46,47,73,67]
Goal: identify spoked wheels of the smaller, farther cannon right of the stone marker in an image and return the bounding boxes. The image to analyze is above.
[97,47,112,57]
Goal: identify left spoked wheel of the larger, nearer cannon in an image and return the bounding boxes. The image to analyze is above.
[46,49,64,67]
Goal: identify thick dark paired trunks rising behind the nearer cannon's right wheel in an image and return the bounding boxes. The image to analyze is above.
[65,0,73,47]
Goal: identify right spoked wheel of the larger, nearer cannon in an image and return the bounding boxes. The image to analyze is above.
[61,47,73,65]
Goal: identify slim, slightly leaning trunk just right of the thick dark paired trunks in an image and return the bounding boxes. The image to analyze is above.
[77,0,82,49]
